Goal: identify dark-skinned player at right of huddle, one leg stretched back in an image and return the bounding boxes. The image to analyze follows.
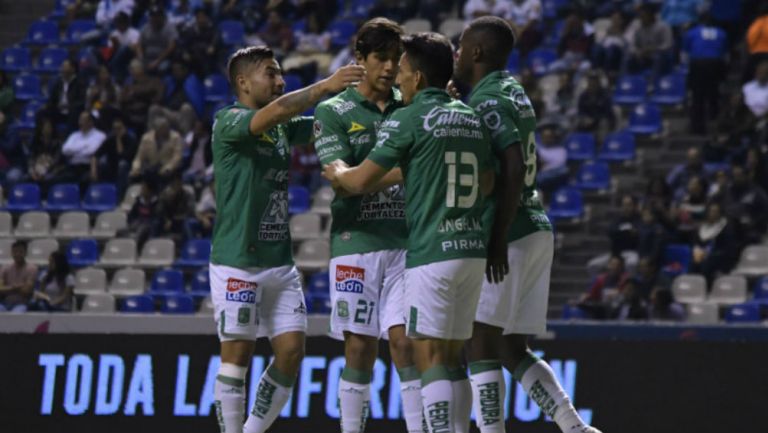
[456,16,599,433]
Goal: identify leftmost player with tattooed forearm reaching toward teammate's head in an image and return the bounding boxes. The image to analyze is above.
[210,47,365,433]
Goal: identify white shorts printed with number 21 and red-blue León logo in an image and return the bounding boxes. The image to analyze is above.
[328,250,405,340]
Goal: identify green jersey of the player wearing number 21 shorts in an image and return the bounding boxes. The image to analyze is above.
[314,87,407,257]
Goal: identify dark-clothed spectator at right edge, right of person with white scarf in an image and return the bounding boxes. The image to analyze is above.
[718,165,768,243]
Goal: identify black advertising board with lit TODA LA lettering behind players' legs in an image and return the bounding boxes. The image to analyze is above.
[0,325,768,433]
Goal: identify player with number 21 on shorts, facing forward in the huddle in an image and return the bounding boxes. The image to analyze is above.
[314,18,422,433]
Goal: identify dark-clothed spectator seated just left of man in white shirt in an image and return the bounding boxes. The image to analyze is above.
[27,117,66,191]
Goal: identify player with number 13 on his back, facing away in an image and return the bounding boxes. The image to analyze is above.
[324,33,493,433]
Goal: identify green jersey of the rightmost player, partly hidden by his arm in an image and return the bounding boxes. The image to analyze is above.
[469,71,552,242]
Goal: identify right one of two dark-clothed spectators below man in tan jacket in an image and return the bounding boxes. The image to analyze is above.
[157,173,195,245]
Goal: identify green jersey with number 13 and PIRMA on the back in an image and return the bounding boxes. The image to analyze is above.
[368,87,492,268]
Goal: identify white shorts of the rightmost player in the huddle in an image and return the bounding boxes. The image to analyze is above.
[475,231,554,335]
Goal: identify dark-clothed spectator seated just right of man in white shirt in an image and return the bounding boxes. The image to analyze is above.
[91,118,137,192]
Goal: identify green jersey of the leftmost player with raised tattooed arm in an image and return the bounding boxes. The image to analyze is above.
[211,103,312,268]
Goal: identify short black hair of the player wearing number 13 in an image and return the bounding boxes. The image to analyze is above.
[403,32,453,89]
